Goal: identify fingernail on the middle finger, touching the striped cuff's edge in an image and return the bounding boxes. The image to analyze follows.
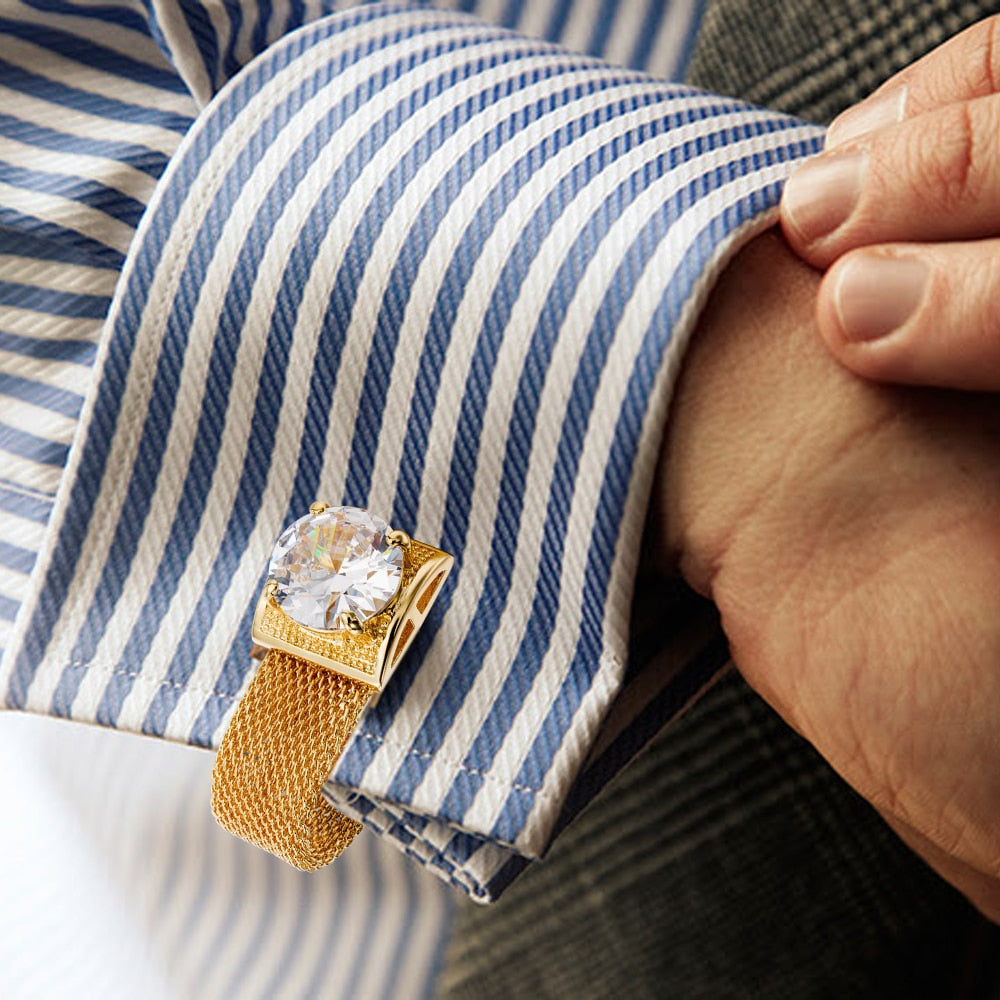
[781,152,868,243]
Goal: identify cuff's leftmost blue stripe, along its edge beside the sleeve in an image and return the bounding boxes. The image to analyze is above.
[5,1,406,708]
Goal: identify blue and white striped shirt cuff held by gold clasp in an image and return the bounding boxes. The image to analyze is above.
[0,5,820,899]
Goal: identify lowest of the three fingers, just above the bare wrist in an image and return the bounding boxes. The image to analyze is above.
[817,240,1000,391]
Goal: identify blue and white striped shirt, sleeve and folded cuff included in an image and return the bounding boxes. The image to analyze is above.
[0,0,820,992]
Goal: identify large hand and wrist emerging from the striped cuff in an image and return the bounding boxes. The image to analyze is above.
[654,233,1000,920]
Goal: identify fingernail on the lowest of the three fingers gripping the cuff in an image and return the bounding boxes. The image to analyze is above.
[834,253,930,340]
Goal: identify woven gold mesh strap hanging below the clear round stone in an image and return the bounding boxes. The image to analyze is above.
[212,649,375,871]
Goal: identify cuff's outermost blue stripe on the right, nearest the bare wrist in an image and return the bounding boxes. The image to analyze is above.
[491,164,816,841]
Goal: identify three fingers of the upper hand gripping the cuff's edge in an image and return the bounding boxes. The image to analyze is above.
[782,17,1000,390]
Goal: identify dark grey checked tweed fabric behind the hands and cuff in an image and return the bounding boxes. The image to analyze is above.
[437,0,1000,1000]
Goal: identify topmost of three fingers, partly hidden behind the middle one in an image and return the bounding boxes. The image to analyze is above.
[826,16,1000,149]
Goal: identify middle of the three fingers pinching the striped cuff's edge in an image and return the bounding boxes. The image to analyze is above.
[781,95,1000,267]
